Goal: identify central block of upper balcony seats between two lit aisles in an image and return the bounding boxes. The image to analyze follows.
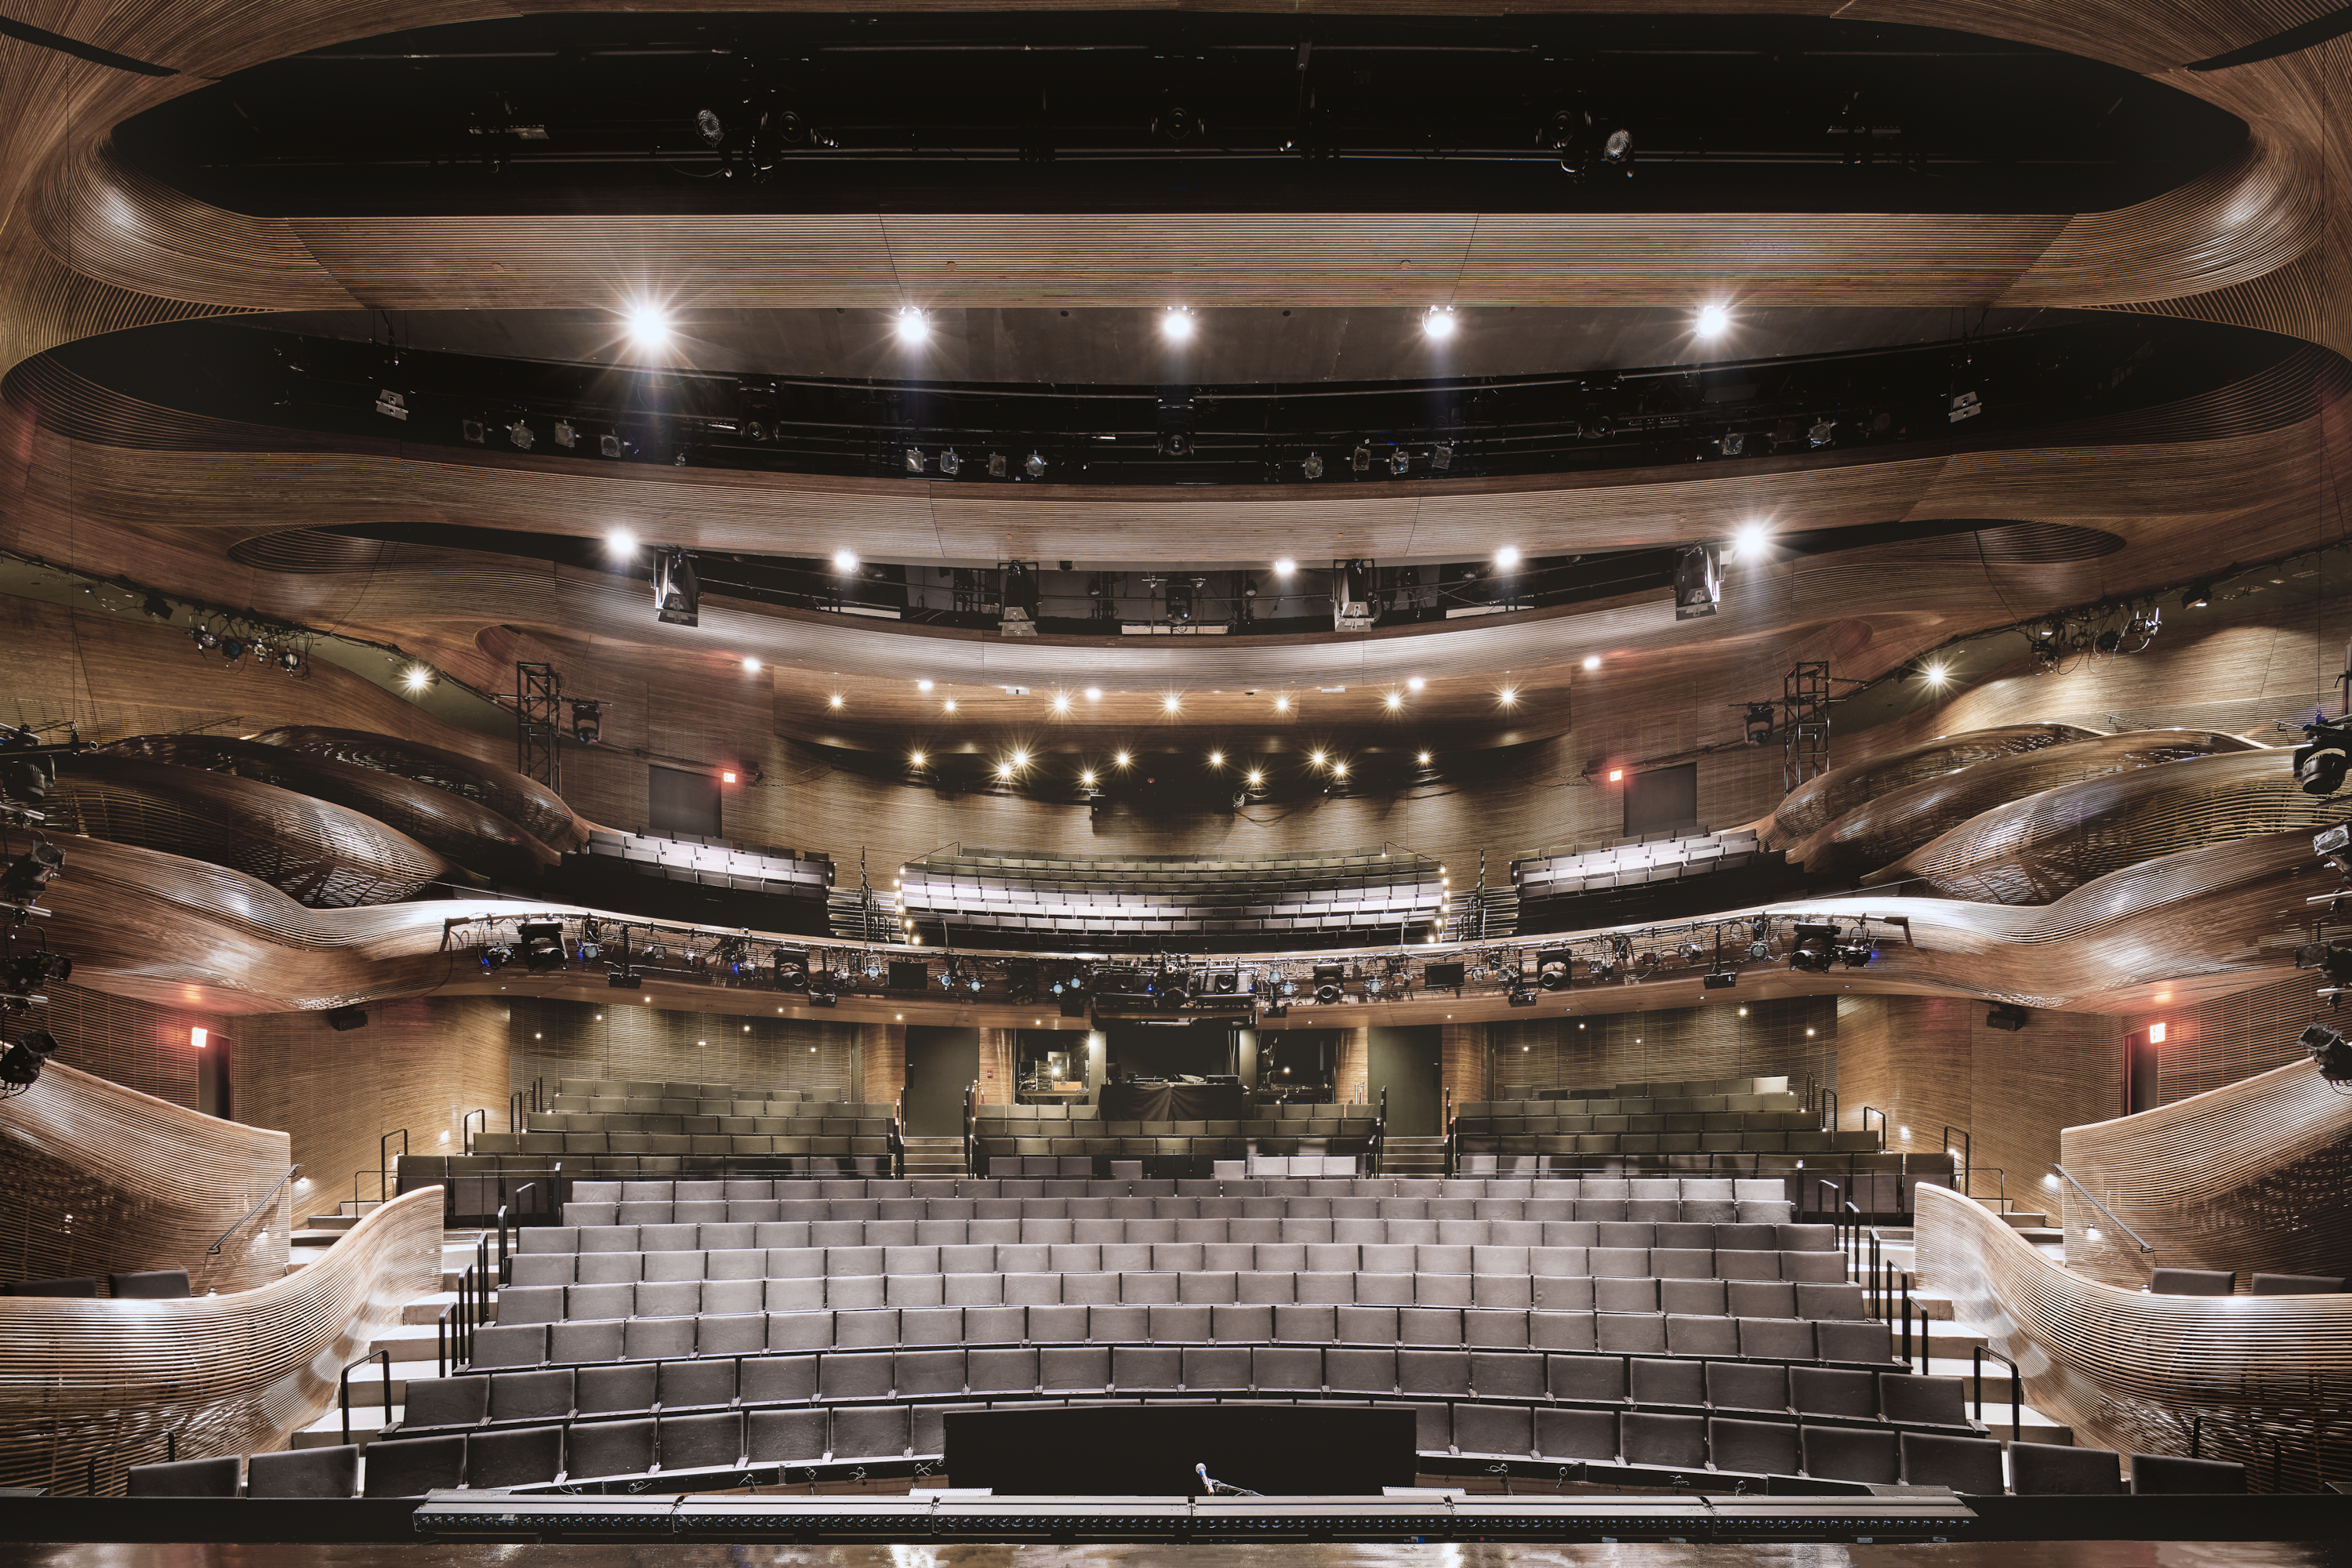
[898,851,1446,949]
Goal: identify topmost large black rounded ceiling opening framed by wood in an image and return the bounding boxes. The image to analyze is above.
[120,12,2244,214]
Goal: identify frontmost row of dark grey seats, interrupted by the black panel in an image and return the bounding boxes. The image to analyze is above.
[129,1401,2246,1497]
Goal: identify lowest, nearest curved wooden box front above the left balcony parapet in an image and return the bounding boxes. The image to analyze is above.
[42,753,456,909]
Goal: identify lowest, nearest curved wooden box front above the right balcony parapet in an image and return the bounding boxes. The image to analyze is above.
[1863,750,2345,902]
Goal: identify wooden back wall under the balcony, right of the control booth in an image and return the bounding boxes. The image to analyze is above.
[1472,987,1839,1100]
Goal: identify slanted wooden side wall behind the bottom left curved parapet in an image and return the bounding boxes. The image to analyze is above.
[0,1060,292,1298]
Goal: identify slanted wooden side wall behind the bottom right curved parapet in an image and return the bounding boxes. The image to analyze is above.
[2058,1060,2352,1290]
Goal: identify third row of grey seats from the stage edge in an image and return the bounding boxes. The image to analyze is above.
[463,1307,1889,1370]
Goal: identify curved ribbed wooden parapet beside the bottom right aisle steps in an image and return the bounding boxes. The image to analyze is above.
[1917,1187,2352,1490]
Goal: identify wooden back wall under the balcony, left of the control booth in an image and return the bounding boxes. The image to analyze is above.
[506,992,856,1105]
